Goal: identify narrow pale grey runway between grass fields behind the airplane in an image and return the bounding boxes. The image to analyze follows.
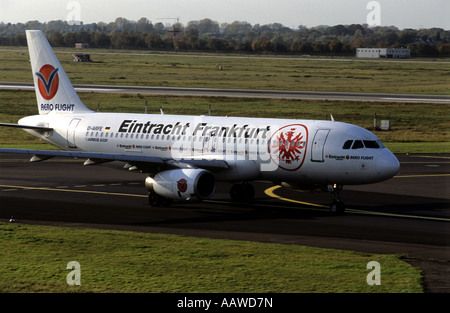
[0,82,450,104]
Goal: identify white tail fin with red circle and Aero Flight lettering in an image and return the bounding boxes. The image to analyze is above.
[26,30,92,114]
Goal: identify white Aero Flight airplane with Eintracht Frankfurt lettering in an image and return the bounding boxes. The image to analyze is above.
[0,30,399,213]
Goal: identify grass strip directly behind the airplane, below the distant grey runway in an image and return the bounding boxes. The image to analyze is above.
[0,91,450,153]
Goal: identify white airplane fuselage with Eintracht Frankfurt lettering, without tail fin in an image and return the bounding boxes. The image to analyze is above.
[19,113,398,185]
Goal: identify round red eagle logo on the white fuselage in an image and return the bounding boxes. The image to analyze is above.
[268,124,308,171]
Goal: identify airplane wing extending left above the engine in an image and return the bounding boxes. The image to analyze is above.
[0,148,228,171]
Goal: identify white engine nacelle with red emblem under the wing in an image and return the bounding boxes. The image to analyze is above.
[145,168,216,200]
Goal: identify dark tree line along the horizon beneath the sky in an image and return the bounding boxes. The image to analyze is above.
[0,17,450,57]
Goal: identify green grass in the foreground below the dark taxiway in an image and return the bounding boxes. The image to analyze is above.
[0,223,423,293]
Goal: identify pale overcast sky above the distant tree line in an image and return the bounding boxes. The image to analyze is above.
[0,0,450,30]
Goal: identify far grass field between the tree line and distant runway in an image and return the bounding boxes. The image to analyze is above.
[0,48,450,95]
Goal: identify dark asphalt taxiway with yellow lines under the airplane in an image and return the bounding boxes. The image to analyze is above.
[0,154,450,293]
